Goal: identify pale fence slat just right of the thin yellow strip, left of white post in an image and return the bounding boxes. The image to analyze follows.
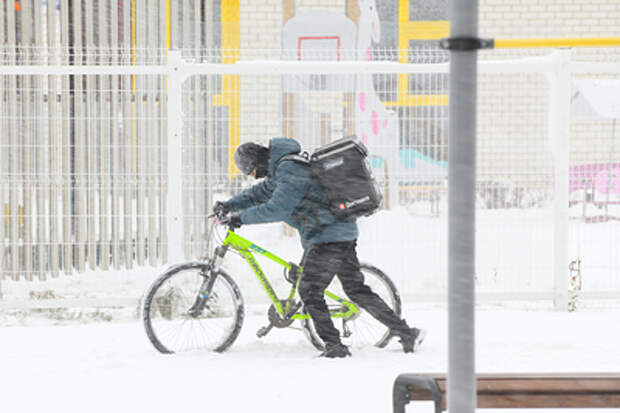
[135,0,146,265]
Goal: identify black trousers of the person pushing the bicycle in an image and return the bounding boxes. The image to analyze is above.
[299,241,408,344]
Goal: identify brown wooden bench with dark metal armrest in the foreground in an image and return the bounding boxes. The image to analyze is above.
[393,373,620,413]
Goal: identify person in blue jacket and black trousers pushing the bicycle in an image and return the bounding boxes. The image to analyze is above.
[213,138,424,358]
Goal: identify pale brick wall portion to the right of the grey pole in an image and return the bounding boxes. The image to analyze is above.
[478,0,620,181]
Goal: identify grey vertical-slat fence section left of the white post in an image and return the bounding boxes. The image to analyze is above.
[0,0,172,279]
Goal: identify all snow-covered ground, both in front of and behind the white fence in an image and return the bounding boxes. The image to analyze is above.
[0,209,620,413]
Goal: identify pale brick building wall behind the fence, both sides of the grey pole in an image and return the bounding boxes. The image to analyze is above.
[235,0,620,184]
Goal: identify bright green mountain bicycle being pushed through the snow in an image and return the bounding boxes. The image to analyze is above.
[142,216,401,353]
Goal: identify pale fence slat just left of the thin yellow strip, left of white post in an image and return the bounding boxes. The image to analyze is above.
[122,1,134,269]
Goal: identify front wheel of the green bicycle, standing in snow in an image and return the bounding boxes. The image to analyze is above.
[142,262,244,354]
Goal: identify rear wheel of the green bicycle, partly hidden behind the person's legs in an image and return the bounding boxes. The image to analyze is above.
[303,264,401,351]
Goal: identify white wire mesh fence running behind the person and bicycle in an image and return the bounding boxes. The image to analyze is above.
[0,2,620,308]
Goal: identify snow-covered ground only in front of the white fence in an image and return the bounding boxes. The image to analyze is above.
[0,305,620,413]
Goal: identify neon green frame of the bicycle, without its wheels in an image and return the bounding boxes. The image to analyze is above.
[222,229,359,320]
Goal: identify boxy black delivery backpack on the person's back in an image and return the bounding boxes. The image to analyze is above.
[278,136,383,221]
